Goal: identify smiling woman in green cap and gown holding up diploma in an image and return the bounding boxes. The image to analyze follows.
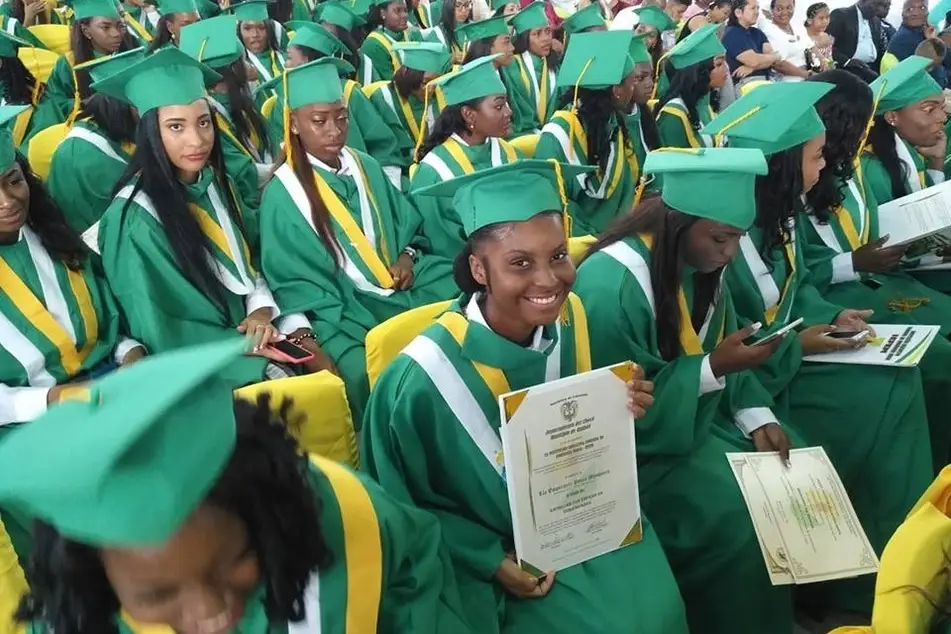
[362,160,692,634]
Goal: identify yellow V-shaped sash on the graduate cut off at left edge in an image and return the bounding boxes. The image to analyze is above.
[0,257,99,377]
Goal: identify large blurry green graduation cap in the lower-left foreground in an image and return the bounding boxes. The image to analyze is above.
[0,341,247,546]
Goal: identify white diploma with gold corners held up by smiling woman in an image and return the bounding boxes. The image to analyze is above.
[499,362,641,574]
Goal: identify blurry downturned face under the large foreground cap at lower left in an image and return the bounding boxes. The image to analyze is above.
[100,505,261,634]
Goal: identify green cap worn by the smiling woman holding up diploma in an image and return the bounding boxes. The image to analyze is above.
[413,159,594,236]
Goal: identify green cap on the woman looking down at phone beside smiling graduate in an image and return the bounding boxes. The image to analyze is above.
[644,148,768,231]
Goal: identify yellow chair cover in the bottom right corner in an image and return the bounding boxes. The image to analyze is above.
[829,467,951,634]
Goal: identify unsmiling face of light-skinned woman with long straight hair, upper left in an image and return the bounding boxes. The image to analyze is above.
[158,98,215,180]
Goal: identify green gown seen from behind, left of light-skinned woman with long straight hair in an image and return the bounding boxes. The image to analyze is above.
[46,119,130,236]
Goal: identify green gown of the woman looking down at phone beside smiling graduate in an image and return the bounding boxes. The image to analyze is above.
[575,237,793,634]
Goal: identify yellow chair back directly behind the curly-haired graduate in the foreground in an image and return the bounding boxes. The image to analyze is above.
[235,372,360,464]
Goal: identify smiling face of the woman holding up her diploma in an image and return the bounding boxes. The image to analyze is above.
[469,213,576,332]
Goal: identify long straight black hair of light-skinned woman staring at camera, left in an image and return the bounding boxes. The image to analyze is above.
[115,106,244,312]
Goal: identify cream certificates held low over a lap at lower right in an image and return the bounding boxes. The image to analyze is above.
[726,447,878,585]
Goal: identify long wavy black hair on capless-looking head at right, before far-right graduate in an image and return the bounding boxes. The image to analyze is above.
[806,69,872,222]
